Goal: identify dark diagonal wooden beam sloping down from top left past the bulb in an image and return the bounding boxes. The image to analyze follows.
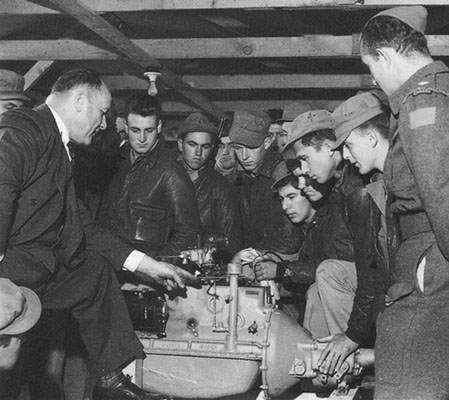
[39,0,224,119]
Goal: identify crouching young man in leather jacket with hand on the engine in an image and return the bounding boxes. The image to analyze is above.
[254,162,354,324]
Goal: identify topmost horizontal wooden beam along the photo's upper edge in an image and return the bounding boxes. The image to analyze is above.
[4,0,447,15]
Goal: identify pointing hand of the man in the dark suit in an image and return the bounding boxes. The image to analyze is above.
[136,255,199,290]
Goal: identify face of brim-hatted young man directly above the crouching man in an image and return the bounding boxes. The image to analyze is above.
[293,140,336,183]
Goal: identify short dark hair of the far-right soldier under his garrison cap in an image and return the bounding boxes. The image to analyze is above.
[360,15,430,59]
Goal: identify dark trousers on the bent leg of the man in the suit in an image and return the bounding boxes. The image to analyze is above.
[41,252,142,375]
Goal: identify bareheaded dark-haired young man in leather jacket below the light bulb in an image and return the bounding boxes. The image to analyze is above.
[99,95,201,256]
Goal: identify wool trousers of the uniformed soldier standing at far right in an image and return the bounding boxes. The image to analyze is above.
[374,233,449,400]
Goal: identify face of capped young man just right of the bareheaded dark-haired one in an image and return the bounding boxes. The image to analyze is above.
[178,132,213,171]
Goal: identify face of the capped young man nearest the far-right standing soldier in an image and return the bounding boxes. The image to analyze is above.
[343,129,375,175]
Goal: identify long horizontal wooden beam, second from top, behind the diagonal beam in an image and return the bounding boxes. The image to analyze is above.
[0,35,449,59]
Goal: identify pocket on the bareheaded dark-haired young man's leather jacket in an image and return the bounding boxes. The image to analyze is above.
[131,203,172,246]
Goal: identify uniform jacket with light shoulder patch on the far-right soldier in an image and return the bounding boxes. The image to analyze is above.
[384,62,449,301]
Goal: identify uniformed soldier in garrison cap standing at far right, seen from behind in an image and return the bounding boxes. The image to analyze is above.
[360,6,449,400]
